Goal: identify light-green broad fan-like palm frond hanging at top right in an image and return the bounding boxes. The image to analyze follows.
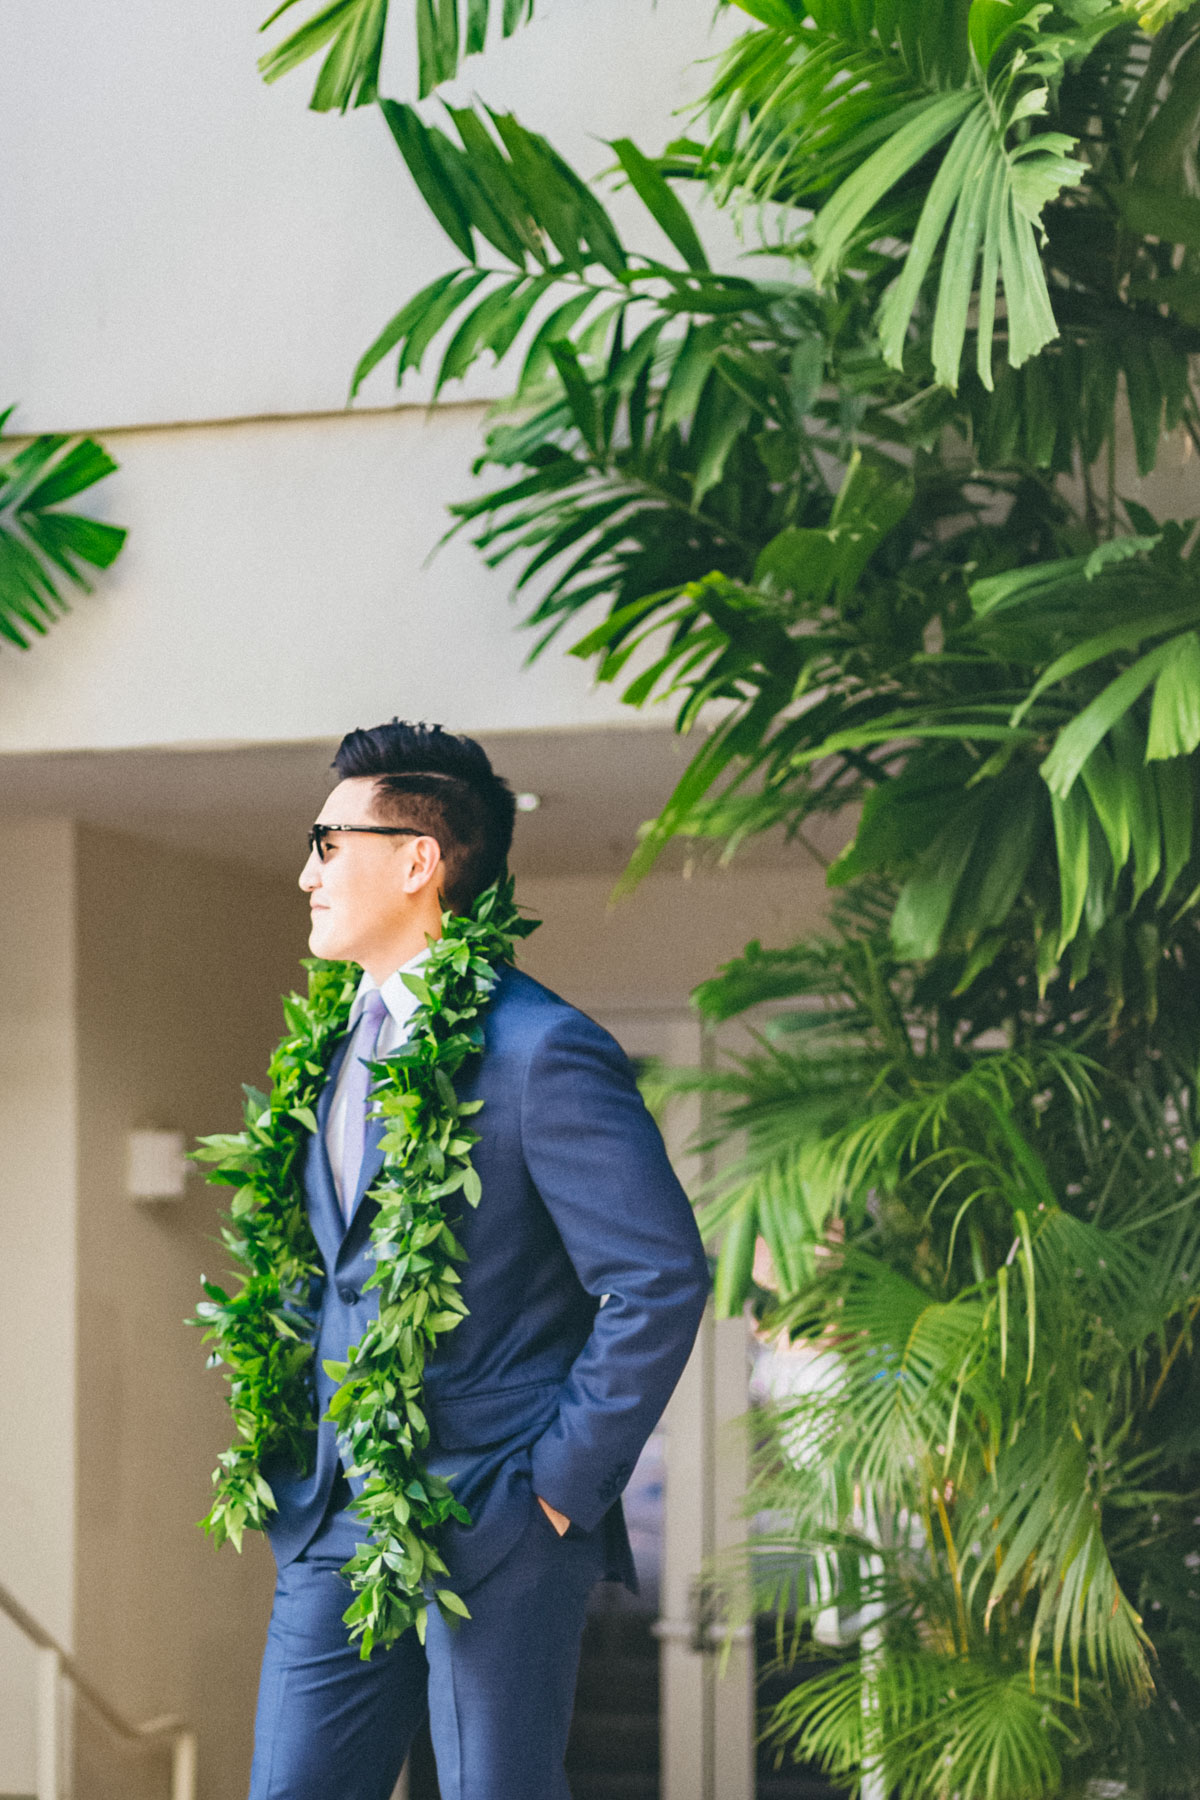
[702,4,1087,389]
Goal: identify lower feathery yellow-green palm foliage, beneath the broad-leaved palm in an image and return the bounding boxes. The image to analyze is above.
[698,889,1200,1800]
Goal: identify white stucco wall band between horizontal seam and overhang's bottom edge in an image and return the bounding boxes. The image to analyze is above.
[0,407,658,752]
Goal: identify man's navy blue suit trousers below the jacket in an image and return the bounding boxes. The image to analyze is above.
[250,1492,604,1800]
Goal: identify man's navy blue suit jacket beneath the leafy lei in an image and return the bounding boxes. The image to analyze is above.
[264,968,709,1591]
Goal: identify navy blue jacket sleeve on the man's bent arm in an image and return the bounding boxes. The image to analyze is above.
[522,1013,709,1530]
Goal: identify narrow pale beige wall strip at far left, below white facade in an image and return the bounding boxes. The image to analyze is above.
[0,821,76,1793]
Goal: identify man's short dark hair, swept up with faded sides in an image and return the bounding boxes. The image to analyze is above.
[333,718,516,913]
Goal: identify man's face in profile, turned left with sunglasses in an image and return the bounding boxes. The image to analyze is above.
[300,778,439,974]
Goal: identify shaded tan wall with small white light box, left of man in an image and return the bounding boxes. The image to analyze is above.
[76,830,306,1800]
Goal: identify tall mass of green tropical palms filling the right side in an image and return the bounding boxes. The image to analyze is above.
[260,0,1200,1800]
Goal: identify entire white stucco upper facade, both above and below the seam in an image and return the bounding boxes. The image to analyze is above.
[0,0,736,756]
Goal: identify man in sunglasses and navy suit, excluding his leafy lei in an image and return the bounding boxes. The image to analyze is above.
[250,720,709,1800]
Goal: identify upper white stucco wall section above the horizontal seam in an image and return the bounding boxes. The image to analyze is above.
[0,0,730,430]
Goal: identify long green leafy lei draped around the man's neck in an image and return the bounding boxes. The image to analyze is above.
[193,880,536,1658]
